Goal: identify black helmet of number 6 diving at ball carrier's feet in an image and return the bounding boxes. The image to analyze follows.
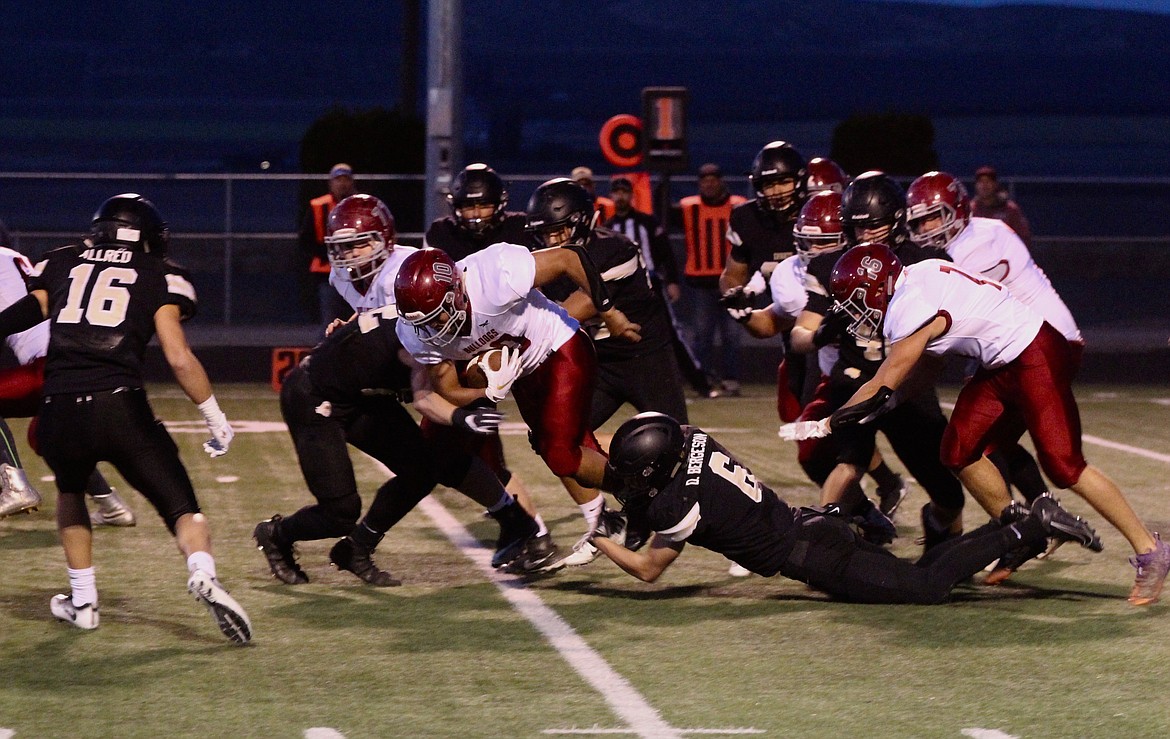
[606,412,686,504]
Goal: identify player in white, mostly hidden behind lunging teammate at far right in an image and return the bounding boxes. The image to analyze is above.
[906,172,1085,585]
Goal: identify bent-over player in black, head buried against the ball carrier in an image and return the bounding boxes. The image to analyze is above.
[253,306,537,587]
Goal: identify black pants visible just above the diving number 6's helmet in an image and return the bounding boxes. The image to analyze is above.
[589,346,688,430]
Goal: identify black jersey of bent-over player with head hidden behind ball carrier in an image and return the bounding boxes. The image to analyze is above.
[305,306,411,405]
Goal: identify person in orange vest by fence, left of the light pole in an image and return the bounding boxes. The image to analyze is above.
[297,163,357,326]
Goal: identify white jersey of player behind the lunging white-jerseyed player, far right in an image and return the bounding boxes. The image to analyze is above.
[947,217,1081,341]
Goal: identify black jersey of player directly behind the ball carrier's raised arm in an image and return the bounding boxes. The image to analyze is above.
[541,228,672,361]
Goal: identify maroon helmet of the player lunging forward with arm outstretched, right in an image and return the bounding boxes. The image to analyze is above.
[828,243,902,340]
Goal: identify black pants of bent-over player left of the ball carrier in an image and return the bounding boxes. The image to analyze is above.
[280,367,470,541]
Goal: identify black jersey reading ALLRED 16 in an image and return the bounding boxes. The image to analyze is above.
[29,244,195,395]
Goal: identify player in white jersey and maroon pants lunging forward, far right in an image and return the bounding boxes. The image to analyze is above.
[784,244,1170,606]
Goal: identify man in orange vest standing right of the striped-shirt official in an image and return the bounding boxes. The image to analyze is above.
[679,164,746,398]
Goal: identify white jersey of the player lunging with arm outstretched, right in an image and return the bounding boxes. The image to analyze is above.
[882,260,1044,368]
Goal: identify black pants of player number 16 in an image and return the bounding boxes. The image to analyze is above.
[36,387,199,533]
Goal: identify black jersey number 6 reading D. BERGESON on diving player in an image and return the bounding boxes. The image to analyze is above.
[645,426,799,576]
